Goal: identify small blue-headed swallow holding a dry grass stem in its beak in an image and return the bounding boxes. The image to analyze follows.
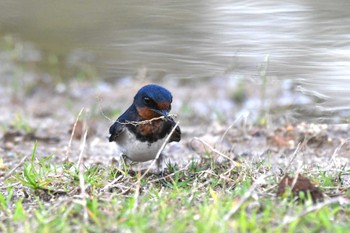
[109,84,181,173]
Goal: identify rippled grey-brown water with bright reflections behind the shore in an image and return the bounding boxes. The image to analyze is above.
[0,0,350,115]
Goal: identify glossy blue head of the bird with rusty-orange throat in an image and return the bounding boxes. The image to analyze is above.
[134,84,173,120]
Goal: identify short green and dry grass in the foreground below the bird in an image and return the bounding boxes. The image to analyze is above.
[0,141,350,232]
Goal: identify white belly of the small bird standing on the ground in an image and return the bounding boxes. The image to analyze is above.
[117,130,166,162]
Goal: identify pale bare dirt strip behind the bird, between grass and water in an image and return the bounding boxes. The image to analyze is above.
[0,74,350,175]
